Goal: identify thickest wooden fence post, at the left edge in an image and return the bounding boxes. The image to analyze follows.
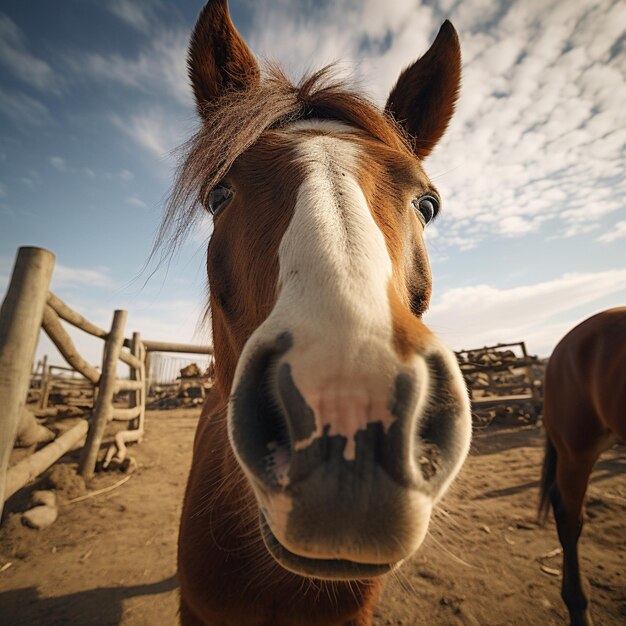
[0,247,55,515]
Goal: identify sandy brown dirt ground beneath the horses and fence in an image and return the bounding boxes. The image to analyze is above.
[0,410,626,626]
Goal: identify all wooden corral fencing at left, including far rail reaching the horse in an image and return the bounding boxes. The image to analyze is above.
[0,248,213,514]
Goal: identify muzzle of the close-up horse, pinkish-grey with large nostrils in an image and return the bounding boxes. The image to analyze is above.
[229,332,470,579]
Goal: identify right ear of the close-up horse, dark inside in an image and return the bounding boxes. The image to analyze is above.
[385,20,461,159]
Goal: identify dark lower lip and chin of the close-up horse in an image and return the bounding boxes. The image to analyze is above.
[259,512,400,580]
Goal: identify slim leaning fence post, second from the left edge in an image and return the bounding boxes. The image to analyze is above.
[79,311,128,480]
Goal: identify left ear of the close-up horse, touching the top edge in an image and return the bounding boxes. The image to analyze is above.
[187,0,259,115]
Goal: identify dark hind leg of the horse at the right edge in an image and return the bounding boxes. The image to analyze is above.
[550,453,597,626]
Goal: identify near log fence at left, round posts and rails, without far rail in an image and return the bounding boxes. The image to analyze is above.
[0,248,146,513]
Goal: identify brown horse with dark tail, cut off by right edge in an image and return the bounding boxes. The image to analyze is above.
[539,307,626,626]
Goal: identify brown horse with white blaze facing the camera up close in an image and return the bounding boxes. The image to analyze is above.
[165,0,470,626]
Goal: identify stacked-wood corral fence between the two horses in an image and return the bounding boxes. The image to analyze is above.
[456,341,545,426]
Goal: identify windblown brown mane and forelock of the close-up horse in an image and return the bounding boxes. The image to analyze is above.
[156,65,410,252]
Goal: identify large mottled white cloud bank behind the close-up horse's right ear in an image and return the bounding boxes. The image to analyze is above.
[241,0,626,249]
